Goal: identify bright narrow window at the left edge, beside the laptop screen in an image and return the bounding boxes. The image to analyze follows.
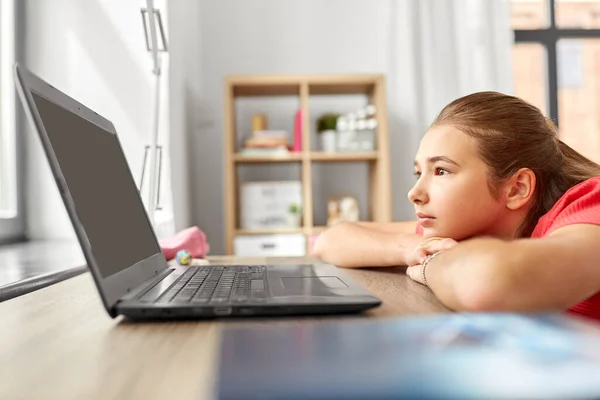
[0,0,24,242]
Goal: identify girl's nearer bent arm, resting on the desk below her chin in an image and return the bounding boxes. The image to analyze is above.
[420,224,600,311]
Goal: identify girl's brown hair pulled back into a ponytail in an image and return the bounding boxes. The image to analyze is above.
[432,92,600,237]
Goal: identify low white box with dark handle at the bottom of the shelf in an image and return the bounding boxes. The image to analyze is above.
[233,233,306,257]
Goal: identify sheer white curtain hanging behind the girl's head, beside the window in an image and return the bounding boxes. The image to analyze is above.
[388,0,514,220]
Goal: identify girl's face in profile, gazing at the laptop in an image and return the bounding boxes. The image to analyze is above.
[408,126,510,240]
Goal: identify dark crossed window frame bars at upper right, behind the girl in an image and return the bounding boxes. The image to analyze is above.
[514,0,600,126]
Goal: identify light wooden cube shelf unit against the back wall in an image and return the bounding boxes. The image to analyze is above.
[225,74,392,255]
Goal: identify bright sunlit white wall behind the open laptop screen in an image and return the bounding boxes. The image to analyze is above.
[24,0,169,239]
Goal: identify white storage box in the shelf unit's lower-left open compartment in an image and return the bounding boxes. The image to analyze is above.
[240,181,302,229]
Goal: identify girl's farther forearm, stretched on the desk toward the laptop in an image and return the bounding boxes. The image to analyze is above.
[313,222,423,267]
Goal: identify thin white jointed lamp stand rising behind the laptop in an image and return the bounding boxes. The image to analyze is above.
[140,0,168,225]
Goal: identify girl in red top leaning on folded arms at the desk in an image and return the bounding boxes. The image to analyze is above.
[314,92,600,319]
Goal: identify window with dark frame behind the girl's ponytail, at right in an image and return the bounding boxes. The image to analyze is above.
[511,0,600,162]
